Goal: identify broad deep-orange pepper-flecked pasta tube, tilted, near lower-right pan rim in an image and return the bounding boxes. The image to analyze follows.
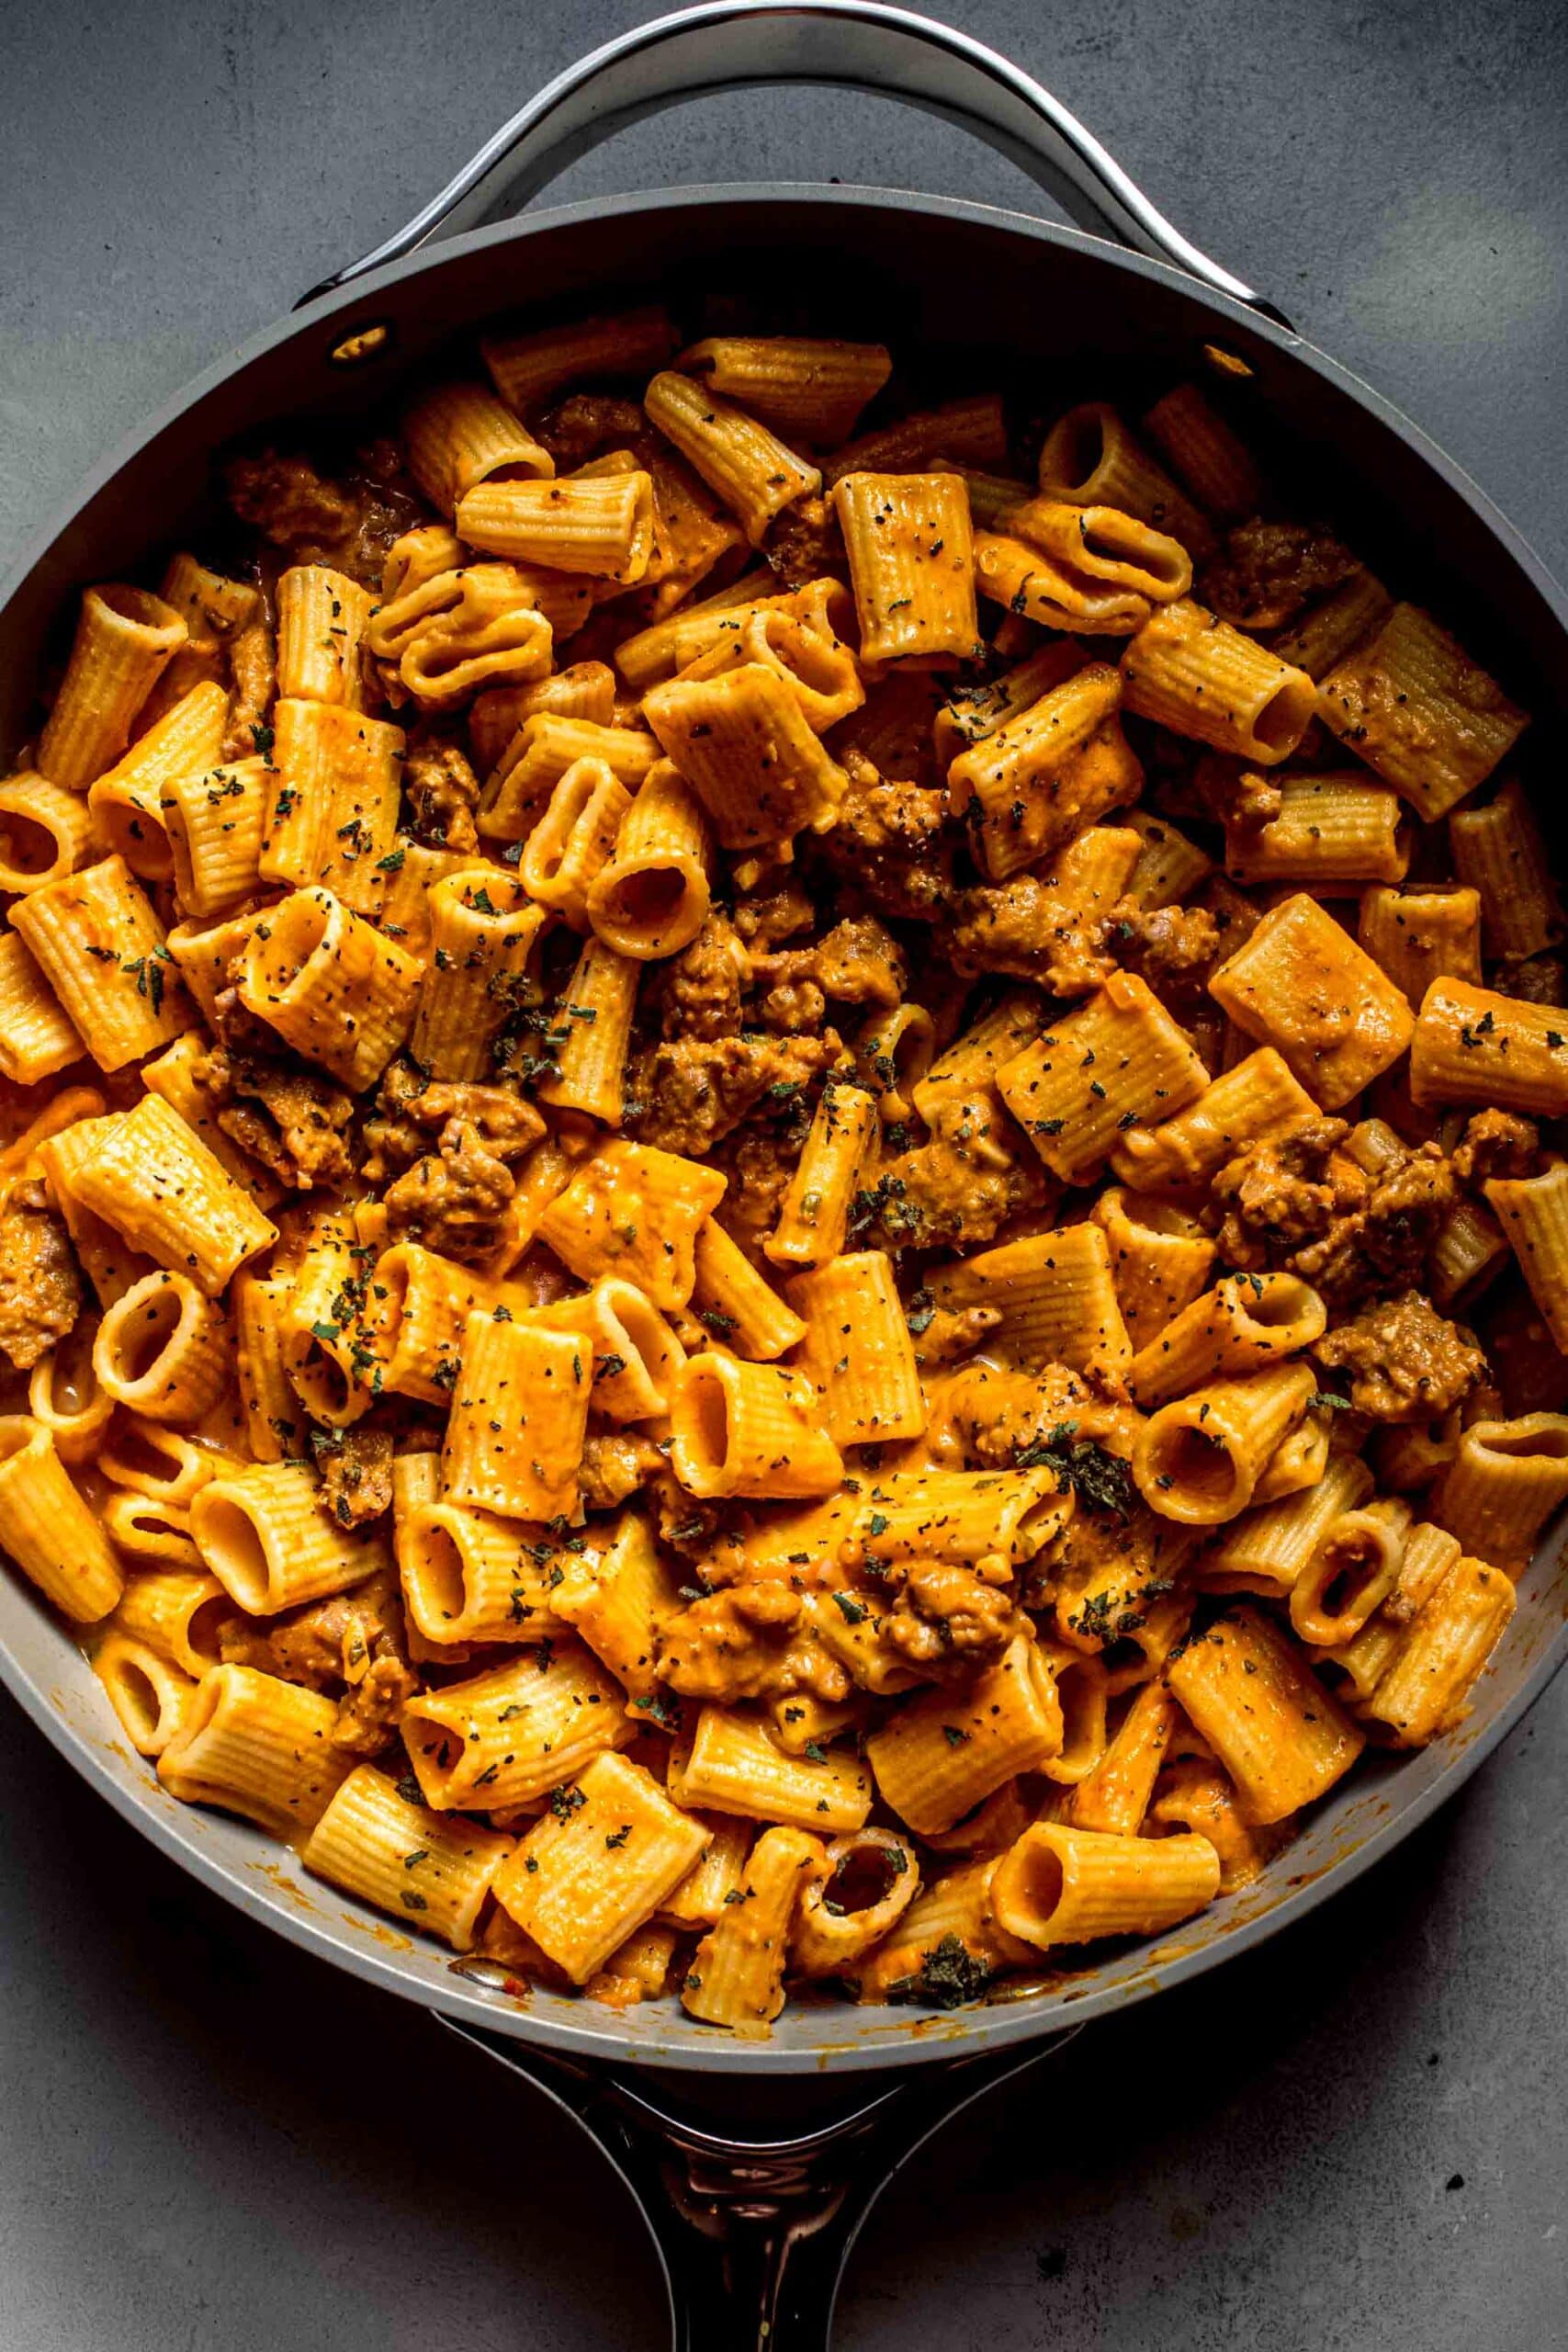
[1166,1604,1363,1823]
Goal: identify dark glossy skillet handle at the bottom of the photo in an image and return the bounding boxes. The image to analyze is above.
[434,2011,1077,2352]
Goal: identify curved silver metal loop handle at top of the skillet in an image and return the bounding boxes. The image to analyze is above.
[301,0,1291,327]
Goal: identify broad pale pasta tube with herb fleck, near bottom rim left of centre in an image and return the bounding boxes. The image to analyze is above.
[496,1755,707,1985]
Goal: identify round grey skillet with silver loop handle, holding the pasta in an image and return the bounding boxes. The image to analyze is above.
[0,0,1568,2352]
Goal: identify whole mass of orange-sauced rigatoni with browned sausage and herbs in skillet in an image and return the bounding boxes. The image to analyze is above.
[0,308,1541,2034]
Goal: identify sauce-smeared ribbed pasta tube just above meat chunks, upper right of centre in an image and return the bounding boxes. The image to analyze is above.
[947,661,1143,882]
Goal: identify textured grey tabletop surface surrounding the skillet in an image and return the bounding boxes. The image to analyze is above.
[0,0,1568,2352]
